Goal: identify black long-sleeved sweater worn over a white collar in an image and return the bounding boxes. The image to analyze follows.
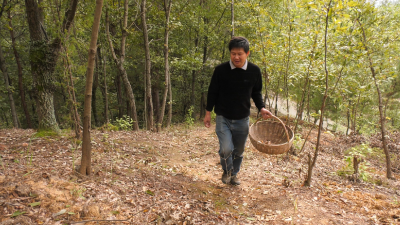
[206,62,265,120]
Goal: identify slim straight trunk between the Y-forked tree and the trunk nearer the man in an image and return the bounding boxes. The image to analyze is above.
[140,0,154,130]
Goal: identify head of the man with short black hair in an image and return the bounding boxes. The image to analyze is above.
[229,36,250,68]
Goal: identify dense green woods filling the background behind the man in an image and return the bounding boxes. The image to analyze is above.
[0,0,400,134]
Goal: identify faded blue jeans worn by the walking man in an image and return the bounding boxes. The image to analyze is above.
[215,115,249,175]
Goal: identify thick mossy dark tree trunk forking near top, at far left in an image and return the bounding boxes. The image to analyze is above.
[25,0,78,133]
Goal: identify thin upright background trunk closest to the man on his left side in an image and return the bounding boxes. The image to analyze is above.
[157,0,172,132]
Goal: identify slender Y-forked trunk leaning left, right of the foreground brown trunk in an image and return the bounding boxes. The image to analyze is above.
[106,3,139,130]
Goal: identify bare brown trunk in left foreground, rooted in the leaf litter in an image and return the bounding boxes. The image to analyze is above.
[79,0,103,175]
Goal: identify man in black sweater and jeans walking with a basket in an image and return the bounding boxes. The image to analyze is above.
[204,37,272,185]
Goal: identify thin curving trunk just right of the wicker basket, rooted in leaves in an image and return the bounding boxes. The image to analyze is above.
[304,0,332,186]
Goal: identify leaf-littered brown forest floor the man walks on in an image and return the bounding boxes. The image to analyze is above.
[0,118,400,225]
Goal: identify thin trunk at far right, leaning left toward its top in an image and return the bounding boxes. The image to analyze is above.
[357,19,394,179]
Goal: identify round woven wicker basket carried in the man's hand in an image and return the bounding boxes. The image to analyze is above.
[249,116,294,155]
